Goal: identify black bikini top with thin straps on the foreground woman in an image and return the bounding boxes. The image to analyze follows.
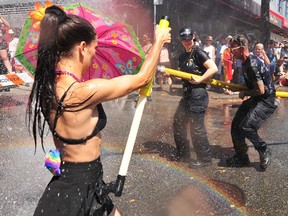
[51,83,107,144]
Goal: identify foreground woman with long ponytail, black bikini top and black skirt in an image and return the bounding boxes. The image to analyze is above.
[28,6,171,216]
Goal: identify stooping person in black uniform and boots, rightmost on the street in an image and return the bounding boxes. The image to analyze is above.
[227,35,279,170]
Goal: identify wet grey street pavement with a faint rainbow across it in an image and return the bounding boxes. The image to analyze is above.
[0,86,288,216]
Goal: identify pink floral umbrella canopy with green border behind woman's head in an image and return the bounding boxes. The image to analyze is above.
[15,3,145,80]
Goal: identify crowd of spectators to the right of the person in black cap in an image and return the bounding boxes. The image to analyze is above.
[179,31,288,91]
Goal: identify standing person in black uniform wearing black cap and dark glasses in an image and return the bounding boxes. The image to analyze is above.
[173,28,217,168]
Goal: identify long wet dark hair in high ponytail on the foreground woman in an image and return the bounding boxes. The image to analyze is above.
[27,6,96,151]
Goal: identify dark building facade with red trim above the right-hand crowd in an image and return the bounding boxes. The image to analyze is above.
[151,0,288,41]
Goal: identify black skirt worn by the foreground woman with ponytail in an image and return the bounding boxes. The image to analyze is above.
[34,158,114,216]
